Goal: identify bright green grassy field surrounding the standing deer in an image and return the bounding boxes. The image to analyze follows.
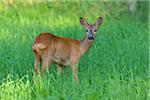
[0,2,150,100]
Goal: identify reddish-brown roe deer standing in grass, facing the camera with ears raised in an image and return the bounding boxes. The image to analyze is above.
[32,17,102,82]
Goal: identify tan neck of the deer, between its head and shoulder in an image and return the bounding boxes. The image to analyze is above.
[80,36,94,55]
